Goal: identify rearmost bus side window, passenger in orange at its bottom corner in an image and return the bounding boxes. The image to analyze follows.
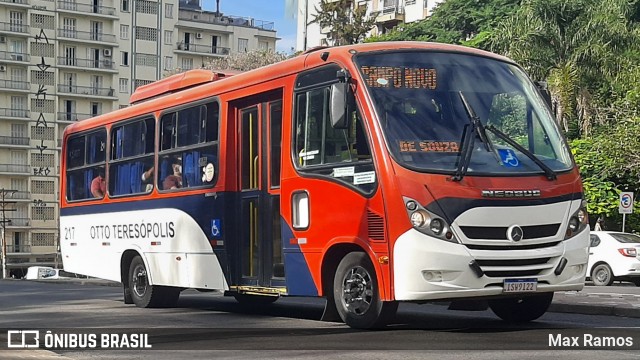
[65,129,107,200]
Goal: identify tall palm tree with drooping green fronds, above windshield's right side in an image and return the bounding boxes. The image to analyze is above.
[491,0,638,137]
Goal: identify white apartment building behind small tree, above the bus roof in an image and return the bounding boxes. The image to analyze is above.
[296,0,444,50]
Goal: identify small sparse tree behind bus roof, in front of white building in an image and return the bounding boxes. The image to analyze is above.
[311,0,375,46]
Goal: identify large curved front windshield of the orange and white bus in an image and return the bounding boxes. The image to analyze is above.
[356,51,573,175]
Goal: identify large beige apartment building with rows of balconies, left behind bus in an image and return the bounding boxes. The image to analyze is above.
[0,0,277,277]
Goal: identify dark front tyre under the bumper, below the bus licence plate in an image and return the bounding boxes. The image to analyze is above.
[489,292,553,323]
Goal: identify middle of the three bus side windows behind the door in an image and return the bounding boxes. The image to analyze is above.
[108,117,155,196]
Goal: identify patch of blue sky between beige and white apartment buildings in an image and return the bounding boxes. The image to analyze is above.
[202,0,296,54]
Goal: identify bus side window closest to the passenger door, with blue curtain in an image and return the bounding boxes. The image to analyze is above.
[158,102,219,191]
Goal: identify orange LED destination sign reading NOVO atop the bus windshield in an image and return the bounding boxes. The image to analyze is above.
[362,66,438,90]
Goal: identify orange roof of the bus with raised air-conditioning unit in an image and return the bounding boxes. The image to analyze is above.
[65,41,513,133]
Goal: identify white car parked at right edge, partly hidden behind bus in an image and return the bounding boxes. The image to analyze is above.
[587,231,640,286]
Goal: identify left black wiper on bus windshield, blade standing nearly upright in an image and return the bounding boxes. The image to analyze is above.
[451,91,502,181]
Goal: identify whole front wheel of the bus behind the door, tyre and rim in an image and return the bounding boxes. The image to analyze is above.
[333,252,398,329]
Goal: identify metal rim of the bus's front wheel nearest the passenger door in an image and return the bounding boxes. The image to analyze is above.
[341,266,373,315]
